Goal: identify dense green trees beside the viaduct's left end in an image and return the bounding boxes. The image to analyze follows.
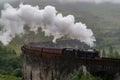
[0,46,22,80]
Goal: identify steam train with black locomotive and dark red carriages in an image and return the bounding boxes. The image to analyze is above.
[22,44,100,58]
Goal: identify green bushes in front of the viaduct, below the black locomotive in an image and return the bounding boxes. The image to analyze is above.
[68,67,114,80]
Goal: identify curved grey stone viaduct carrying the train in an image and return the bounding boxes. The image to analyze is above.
[22,42,120,80]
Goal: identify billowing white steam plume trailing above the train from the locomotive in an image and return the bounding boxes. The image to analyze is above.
[0,4,95,46]
